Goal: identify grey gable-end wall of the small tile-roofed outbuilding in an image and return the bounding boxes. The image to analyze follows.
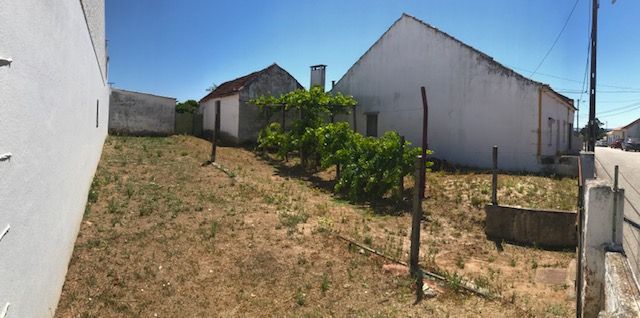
[238,67,301,142]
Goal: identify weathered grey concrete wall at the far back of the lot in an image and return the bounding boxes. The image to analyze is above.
[109,89,176,136]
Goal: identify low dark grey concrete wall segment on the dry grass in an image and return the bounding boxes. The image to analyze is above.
[485,205,577,248]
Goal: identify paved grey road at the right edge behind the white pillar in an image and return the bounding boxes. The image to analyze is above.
[596,147,640,277]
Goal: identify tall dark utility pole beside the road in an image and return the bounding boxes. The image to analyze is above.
[587,0,599,151]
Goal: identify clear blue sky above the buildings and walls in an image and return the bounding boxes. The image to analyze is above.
[106,0,640,128]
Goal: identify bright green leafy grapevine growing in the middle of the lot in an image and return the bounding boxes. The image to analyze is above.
[251,87,431,200]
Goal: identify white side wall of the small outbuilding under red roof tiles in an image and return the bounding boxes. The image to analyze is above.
[200,94,240,142]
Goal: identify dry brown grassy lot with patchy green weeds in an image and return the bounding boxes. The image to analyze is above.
[56,136,576,317]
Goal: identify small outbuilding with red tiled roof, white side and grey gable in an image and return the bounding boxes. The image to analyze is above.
[200,64,302,144]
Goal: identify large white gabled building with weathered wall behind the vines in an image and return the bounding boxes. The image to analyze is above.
[333,14,580,171]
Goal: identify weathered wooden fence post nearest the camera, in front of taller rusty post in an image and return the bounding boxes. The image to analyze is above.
[409,156,424,302]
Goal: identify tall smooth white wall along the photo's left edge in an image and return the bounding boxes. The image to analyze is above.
[0,0,109,318]
